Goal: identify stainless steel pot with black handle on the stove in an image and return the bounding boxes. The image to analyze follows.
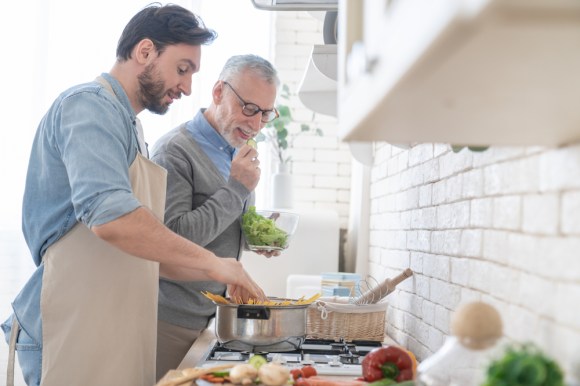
[215,304,308,352]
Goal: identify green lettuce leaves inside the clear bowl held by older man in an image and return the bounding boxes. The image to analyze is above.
[242,206,288,248]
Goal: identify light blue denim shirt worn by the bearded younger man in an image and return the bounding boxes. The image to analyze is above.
[2,73,141,370]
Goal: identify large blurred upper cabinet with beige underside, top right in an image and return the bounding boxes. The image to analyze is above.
[338,0,580,146]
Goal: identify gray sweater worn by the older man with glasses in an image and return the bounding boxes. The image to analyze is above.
[151,119,254,329]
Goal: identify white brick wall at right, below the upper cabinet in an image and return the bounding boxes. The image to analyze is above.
[370,143,580,382]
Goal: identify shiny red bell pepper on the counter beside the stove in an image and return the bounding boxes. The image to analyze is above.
[362,346,414,382]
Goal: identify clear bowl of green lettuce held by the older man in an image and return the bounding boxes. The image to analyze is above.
[242,206,300,252]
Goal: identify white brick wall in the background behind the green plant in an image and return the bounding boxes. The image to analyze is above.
[273,11,351,228]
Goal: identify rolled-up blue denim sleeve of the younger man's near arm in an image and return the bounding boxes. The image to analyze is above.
[55,91,141,227]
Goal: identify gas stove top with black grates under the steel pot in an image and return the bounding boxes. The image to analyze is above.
[197,339,381,376]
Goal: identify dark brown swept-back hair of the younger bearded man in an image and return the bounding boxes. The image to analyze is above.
[117,3,217,61]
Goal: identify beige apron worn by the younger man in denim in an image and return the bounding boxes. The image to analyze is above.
[40,77,167,386]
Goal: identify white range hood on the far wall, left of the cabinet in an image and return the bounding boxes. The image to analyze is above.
[298,44,338,117]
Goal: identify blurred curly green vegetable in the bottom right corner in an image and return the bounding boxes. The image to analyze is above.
[482,343,564,386]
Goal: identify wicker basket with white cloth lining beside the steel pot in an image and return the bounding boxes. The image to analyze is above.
[306,299,387,342]
